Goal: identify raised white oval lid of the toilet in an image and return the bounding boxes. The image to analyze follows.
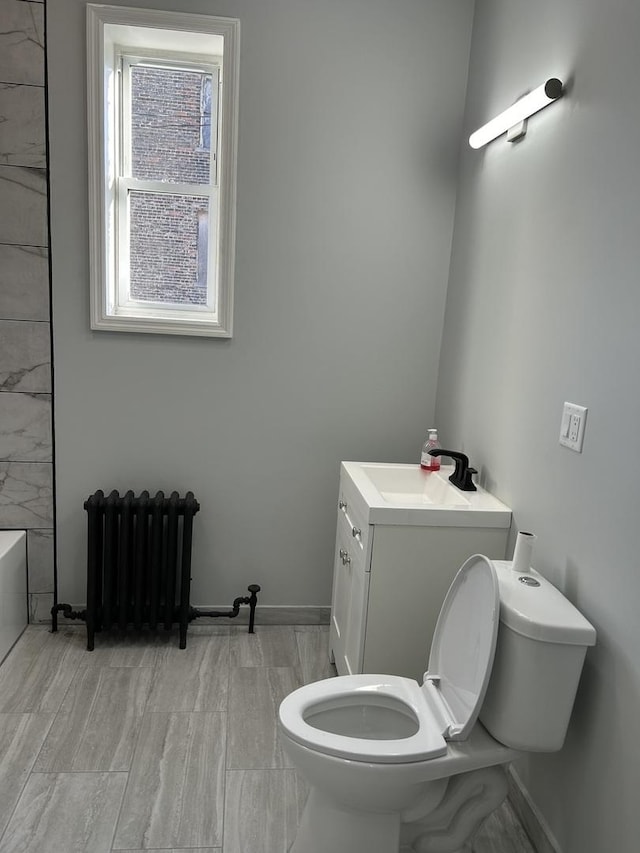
[423,554,500,740]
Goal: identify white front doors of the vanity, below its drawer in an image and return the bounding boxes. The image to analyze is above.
[329,513,369,675]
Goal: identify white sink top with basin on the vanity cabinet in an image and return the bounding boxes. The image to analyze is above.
[342,462,511,528]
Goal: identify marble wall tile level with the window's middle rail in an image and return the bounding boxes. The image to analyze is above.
[0,166,48,246]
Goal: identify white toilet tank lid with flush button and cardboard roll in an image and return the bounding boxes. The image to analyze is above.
[493,560,596,646]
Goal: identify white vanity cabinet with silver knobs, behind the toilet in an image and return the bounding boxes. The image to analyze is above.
[330,462,511,681]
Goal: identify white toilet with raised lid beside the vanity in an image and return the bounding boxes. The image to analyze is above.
[279,555,595,853]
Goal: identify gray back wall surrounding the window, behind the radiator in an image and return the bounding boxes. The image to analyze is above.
[48,0,472,605]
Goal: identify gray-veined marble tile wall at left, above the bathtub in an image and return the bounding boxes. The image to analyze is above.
[0,0,53,621]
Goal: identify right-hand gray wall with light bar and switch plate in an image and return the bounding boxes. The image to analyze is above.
[436,0,640,853]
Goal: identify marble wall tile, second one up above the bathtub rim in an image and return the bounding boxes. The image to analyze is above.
[0,392,51,462]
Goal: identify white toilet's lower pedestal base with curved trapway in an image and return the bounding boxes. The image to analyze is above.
[290,765,507,853]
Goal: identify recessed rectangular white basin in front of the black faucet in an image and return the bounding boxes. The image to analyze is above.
[362,465,469,506]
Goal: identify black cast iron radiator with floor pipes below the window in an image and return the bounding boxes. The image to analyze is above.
[51,490,260,651]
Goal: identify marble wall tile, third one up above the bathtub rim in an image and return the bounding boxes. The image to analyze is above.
[0,320,51,394]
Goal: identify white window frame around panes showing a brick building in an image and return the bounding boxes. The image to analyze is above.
[87,4,240,338]
